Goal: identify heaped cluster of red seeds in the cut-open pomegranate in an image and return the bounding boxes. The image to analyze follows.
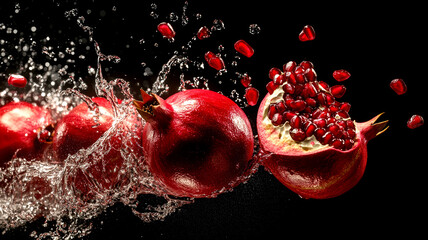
[266,61,356,150]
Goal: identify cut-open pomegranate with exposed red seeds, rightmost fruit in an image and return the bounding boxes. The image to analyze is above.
[257,61,388,199]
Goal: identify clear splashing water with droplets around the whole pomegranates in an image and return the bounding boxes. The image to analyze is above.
[0,2,258,239]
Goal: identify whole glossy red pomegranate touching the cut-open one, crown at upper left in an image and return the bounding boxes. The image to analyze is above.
[134,89,254,198]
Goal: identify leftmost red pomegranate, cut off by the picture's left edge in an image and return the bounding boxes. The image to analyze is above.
[0,102,52,167]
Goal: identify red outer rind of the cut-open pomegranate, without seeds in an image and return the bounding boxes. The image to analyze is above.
[257,94,388,199]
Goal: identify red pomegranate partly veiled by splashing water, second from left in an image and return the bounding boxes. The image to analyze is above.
[51,97,142,200]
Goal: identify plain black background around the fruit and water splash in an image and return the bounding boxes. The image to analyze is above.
[0,0,428,239]
